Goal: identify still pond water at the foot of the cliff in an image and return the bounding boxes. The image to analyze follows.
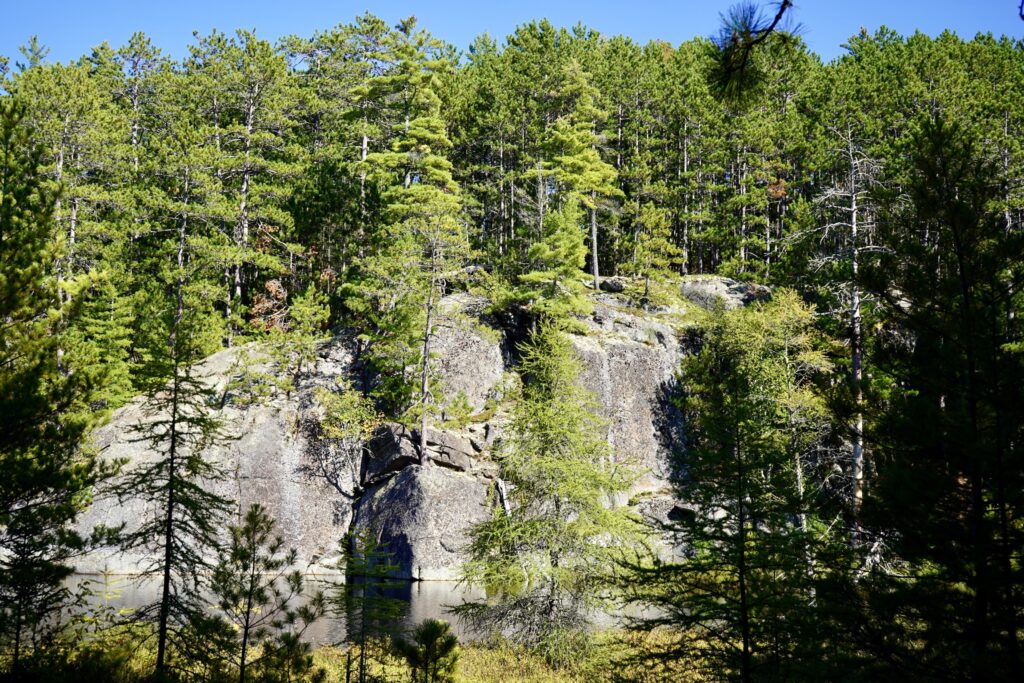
[71,574,483,644]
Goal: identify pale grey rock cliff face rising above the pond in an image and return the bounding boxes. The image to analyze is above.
[81,279,764,581]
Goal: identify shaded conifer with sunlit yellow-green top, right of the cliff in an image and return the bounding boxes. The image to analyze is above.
[622,291,846,681]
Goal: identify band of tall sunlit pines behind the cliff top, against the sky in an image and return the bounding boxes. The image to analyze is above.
[5,16,1024,399]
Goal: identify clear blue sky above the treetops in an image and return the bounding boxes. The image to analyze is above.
[6,0,1024,61]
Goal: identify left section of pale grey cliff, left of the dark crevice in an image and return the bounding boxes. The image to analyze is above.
[79,341,359,573]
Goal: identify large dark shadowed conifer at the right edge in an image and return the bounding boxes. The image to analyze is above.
[864,116,1024,680]
